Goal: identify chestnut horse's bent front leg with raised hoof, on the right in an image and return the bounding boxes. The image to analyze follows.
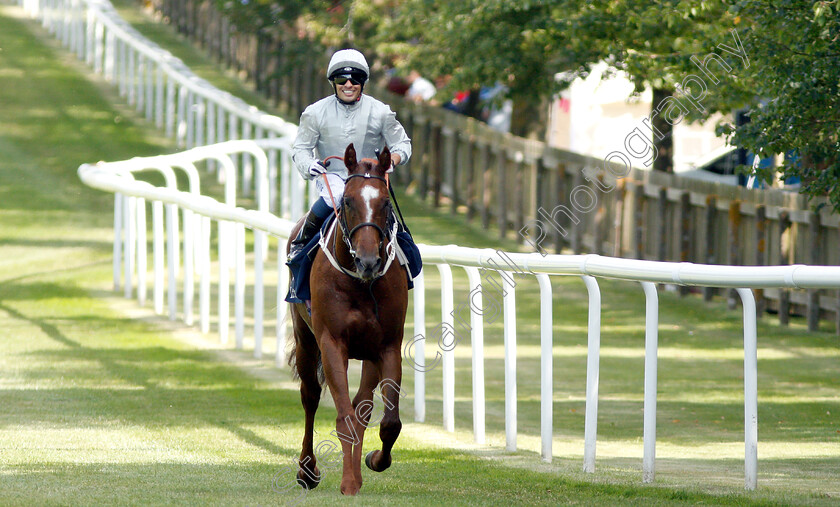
[365,346,403,472]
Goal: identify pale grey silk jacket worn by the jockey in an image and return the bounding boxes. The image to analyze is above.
[292,94,411,188]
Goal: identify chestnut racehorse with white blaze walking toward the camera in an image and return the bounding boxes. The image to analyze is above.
[289,144,408,495]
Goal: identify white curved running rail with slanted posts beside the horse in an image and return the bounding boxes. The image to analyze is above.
[79,140,840,489]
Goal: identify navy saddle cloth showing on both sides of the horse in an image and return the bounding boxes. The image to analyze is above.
[286,215,423,303]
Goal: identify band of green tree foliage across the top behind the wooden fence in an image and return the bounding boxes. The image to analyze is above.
[218,0,840,210]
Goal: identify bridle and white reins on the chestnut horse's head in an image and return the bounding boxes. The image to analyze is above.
[319,170,399,282]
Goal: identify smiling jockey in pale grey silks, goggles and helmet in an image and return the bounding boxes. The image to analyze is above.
[289,49,411,259]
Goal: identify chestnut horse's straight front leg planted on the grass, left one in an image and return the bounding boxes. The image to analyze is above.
[320,337,361,495]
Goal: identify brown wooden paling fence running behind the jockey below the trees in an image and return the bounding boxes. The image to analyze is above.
[144,0,840,335]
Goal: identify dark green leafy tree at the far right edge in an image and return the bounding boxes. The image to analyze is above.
[719,0,840,212]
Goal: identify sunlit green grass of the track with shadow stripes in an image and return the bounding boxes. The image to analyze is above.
[0,1,840,505]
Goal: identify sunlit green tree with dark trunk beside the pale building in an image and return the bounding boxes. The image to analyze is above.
[401,0,748,171]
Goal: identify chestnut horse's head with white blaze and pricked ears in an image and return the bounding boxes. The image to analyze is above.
[343,144,391,280]
